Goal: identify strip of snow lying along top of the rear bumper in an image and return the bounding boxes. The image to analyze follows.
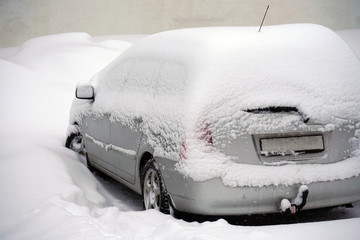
[181,157,360,187]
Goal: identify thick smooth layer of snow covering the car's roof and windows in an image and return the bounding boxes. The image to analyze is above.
[95,24,360,122]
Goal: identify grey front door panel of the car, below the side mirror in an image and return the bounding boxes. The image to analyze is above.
[84,114,114,172]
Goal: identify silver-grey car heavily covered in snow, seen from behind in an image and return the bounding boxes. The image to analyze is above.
[66,24,360,215]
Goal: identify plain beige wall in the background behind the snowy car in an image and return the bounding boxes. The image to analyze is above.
[0,0,360,47]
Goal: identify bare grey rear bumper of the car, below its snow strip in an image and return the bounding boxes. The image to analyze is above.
[159,160,360,215]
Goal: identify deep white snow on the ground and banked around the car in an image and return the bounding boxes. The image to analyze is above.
[0,30,360,240]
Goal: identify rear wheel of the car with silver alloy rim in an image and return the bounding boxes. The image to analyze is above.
[141,159,170,214]
